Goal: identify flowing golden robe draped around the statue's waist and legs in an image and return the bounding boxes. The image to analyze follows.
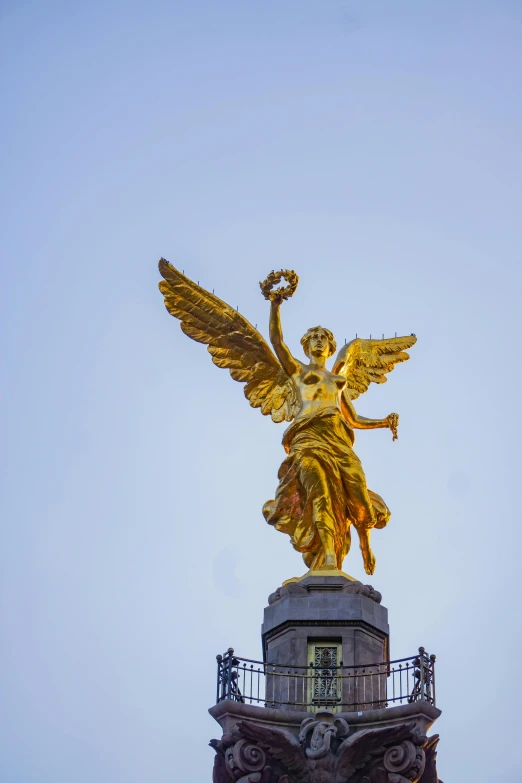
[263,407,390,570]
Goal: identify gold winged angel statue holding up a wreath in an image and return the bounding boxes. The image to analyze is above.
[159,258,417,574]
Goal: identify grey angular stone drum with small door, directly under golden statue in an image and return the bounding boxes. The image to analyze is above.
[262,575,389,711]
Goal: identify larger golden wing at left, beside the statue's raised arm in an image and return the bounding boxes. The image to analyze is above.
[159,258,299,422]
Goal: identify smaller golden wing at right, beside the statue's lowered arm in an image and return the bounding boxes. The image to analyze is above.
[332,334,417,400]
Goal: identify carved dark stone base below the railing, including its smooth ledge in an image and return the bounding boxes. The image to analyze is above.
[210,701,441,783]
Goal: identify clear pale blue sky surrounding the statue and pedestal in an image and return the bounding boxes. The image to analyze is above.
[0,0,522,783]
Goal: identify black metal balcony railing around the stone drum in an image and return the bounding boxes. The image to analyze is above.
[216,647,435,712]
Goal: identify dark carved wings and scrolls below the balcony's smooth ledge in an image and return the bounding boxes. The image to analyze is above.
[211,710,438,783]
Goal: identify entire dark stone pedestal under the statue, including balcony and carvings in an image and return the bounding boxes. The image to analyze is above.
[210,573,441,783]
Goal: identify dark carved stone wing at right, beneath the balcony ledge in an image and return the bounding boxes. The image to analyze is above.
[335,723,415,783]
